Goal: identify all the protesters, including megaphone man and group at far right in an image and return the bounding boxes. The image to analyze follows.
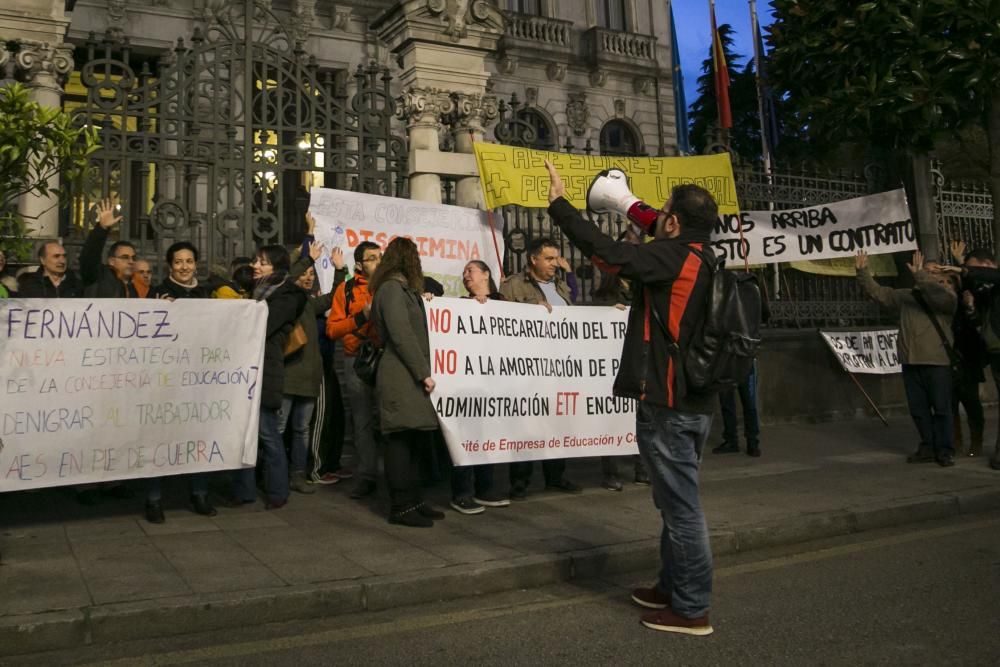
[0,180,1000,635]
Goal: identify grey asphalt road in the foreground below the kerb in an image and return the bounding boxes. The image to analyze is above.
[8,513,1000,667]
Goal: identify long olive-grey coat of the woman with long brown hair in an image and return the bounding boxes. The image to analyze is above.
[372,276,438,433]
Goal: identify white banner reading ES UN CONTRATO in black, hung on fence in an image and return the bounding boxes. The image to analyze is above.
[712,189,917,267]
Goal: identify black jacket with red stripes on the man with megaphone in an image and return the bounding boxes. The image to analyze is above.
[549,198,715,414]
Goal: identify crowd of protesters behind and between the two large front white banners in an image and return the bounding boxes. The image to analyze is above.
[0,200,664,527]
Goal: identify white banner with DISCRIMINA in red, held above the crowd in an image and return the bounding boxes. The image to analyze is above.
[309,188,503,296]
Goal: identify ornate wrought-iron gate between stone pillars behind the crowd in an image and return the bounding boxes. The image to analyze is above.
[66,0,407,274]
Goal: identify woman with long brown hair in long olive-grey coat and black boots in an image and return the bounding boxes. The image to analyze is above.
[369,237,444,528]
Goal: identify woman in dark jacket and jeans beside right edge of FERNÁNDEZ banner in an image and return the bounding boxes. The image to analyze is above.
[232,245,306,509]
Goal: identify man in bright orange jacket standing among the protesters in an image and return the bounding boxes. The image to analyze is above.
[326,241,382,500]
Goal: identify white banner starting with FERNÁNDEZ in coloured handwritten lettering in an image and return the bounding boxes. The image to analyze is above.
[0,299,267,491]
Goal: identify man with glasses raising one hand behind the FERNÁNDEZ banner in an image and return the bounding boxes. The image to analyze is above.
[80,199,139,299]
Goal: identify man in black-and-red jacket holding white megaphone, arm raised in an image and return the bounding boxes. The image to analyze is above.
[545,161,718,635]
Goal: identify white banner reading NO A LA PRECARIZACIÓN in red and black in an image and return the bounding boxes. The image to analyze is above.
[426,299,638,465]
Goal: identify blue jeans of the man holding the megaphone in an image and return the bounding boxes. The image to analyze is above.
[635,401,712,618]
